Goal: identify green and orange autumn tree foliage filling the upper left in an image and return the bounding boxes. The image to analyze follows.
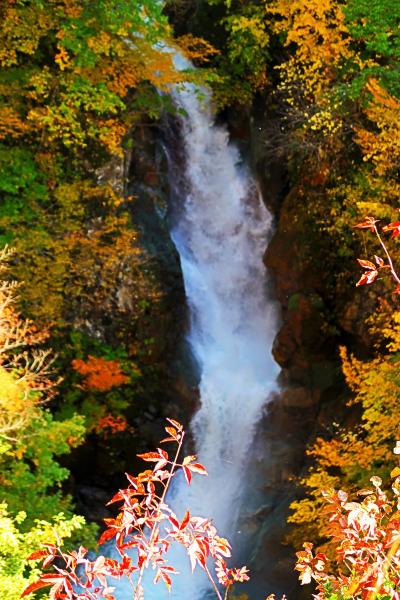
[0,0,208,328]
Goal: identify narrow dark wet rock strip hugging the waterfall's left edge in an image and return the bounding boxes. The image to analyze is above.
[128,120,202,423]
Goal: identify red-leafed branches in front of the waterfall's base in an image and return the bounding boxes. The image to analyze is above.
[22,419,249,600]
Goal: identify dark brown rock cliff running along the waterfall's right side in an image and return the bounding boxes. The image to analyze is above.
[232,86,388,598]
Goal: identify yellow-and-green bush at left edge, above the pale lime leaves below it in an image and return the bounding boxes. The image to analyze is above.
[0,250,93,540]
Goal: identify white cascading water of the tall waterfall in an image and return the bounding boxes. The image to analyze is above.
[111,55,278,600]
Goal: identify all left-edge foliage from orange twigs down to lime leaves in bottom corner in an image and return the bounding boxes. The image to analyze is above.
[0,248,97,600]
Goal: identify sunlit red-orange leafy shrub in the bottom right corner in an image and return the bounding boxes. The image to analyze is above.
[296,468,400,600]
